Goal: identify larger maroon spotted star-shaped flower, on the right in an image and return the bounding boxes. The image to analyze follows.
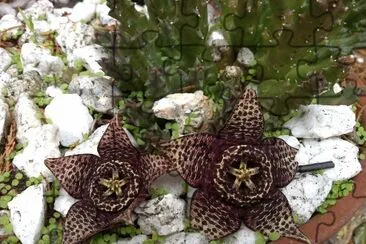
[162,89,309,242]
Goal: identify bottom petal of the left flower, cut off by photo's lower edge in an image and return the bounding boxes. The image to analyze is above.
[62,200,132,244]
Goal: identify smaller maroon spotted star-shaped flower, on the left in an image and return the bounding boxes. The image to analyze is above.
[45,118,175,244]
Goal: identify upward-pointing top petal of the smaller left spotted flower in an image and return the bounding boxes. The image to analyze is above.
[98,117,139,163]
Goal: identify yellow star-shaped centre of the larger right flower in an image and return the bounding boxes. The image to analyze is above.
[229,162,259,191]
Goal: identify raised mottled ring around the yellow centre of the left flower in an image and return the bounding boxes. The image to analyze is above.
[89,160,143,212]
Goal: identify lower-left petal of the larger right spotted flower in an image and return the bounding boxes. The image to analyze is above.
[190,190,241,240]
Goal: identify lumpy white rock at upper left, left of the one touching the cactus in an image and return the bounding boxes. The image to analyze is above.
[21,43,65,76]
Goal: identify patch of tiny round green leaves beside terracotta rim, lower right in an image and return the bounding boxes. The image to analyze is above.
[316,180,354,214]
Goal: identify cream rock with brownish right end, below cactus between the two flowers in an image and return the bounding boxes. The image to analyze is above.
[153,91,213,132]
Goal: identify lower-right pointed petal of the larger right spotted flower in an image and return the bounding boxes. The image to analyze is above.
[243,191,310,243]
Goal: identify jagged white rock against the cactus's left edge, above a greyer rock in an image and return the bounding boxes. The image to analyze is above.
[68,44,109,73]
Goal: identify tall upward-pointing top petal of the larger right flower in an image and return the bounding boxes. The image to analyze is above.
[219,89,263,142]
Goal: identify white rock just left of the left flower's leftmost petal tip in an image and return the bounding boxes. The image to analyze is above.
[13,124,61,181]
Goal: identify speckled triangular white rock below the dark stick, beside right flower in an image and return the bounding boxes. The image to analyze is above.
[281,174,333,224]
